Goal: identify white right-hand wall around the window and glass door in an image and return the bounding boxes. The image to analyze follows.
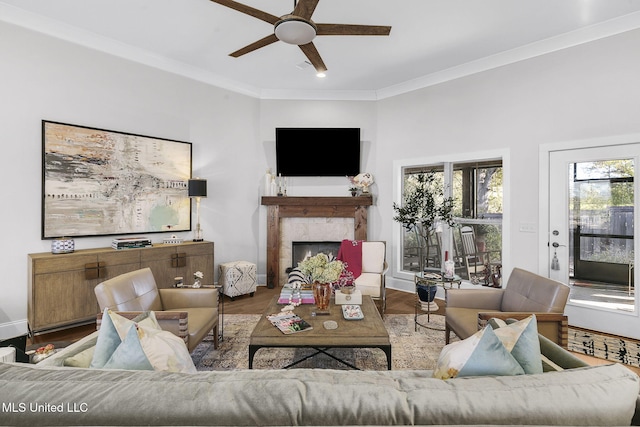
[375,27,640,294]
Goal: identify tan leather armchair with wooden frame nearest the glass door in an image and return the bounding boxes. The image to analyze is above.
[445,268,569,348]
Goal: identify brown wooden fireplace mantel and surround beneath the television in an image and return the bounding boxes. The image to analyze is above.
[262,196,373,289]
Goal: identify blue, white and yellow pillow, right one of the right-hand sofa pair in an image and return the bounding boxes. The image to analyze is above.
[493,314,542,374]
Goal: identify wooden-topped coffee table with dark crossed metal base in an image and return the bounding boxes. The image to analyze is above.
[249,295,391,370]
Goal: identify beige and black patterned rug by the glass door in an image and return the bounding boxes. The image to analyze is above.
[568,327,640,367]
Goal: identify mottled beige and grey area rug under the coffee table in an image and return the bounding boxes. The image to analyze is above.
[191,314,444,371]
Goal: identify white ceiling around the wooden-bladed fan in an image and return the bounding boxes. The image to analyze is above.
[0,0,640,99]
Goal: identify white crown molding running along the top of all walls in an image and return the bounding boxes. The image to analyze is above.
[0,3,640,101]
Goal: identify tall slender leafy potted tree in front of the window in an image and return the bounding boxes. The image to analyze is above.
[393,171,454,299]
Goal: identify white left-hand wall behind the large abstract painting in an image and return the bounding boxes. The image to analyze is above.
[0,22,264,339]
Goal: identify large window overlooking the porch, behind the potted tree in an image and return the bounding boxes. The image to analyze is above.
[400,159,503,282]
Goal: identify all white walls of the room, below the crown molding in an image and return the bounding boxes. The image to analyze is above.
[0,23,640,338]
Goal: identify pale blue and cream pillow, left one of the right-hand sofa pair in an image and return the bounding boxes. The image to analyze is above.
[433,326,524,380]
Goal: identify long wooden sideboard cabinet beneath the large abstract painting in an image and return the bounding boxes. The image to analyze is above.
[27,242,215,333]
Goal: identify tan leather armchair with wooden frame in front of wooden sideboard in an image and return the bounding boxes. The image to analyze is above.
[94,268,218,352]
